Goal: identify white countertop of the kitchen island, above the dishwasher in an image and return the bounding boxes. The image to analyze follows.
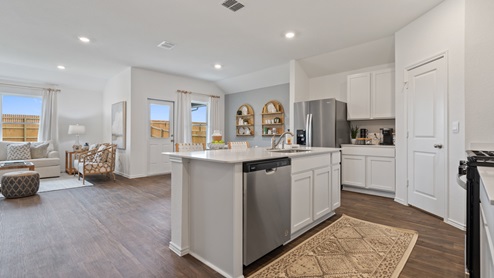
[162,147,341,163]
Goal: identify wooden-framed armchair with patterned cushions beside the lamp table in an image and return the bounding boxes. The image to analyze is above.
[76,143,117,184]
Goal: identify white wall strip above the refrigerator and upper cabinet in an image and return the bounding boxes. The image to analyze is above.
[309,64,394,102]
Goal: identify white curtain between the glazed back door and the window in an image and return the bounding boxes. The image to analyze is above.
[175,92,192,143]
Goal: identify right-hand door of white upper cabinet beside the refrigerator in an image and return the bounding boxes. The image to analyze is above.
[371,69,395,119]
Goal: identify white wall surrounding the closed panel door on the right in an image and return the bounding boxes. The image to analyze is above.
[395,0,465,226]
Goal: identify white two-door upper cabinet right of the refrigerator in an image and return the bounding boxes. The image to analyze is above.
[347,69,395,120]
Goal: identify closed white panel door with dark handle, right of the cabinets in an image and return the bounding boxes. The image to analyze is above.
[405,56,447,218]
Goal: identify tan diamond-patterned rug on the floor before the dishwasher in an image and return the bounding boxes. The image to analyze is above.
[248,215,418,278]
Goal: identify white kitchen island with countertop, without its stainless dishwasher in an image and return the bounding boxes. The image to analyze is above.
[163,148,340,277]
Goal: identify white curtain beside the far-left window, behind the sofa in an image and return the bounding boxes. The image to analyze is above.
[38,89,58,150]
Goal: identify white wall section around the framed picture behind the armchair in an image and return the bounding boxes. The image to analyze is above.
[101,68,132,177]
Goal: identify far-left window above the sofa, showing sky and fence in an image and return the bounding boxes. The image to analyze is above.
[0,94,43,142]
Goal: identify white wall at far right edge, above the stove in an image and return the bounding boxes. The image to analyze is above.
[465,0,494,148]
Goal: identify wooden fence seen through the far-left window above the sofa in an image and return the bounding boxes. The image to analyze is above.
[2,114,39,142]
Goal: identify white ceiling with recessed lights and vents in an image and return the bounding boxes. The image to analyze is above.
[0,0,443,90]
